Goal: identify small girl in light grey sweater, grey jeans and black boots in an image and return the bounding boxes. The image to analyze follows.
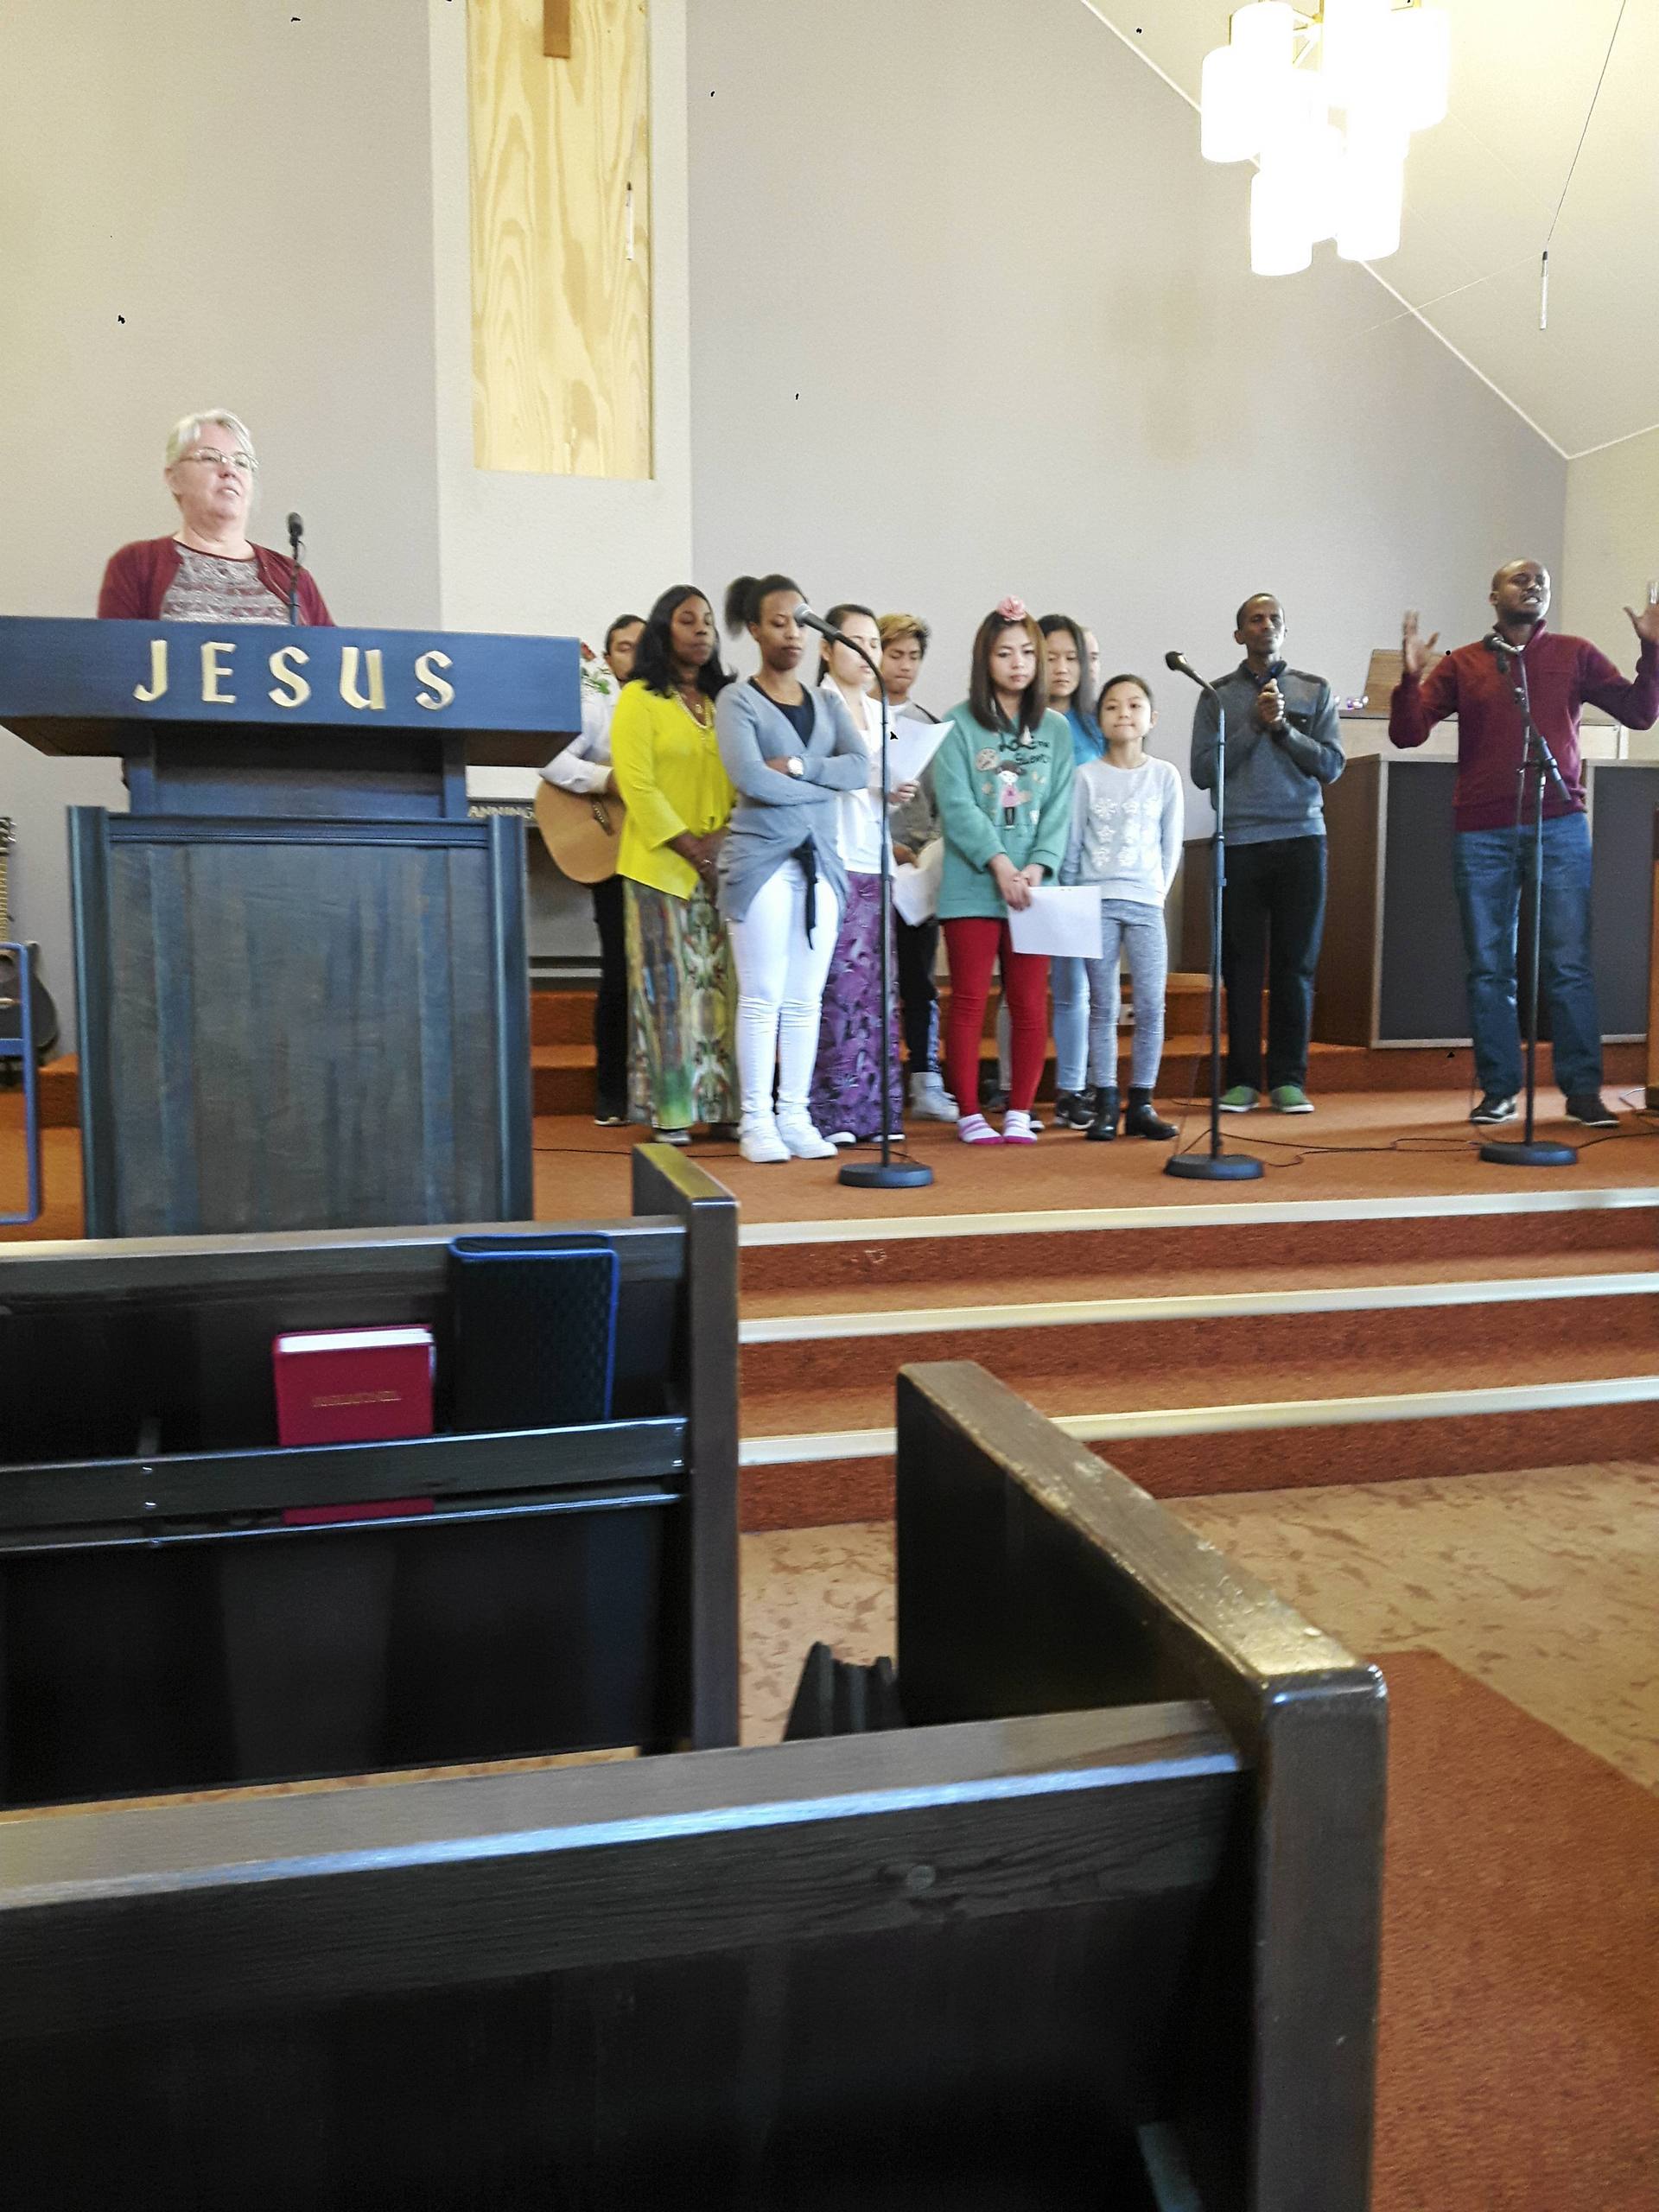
[1059,675,1185,1141]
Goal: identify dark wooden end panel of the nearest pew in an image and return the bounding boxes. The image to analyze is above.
[898,1363,1387,2212]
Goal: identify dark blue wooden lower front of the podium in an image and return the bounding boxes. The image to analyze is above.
[71,807,536,1236]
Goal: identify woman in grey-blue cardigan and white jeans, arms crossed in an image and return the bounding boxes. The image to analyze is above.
[715,575,869,1161]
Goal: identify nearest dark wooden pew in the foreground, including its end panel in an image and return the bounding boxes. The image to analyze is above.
[0,1367,1385,2212]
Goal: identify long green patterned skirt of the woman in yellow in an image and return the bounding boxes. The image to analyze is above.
[626,882,736,1128]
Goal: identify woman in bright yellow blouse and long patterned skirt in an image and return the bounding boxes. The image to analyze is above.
[611,584,736,1144]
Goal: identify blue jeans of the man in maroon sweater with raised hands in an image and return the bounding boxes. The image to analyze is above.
[1453,814,1601,1097]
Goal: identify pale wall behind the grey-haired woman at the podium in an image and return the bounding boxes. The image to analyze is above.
[0,0,448,1011]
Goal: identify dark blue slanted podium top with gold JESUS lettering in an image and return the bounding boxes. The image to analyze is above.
[0,617,582,766]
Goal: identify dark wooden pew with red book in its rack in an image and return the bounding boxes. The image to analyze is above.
[0,1146,736,1805]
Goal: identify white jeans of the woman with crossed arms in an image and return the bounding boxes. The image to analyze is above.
[726,861,841,1126]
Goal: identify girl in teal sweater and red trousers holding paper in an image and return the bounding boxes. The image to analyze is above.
[933,600,1073,1144]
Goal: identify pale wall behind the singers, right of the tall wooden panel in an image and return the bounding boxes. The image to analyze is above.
[688,0,1564,818]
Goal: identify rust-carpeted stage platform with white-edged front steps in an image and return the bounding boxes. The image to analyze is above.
[13,1089,1659,1529]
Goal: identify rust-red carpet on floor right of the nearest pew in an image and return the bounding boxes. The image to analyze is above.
[1374,1652,1659,2212]
